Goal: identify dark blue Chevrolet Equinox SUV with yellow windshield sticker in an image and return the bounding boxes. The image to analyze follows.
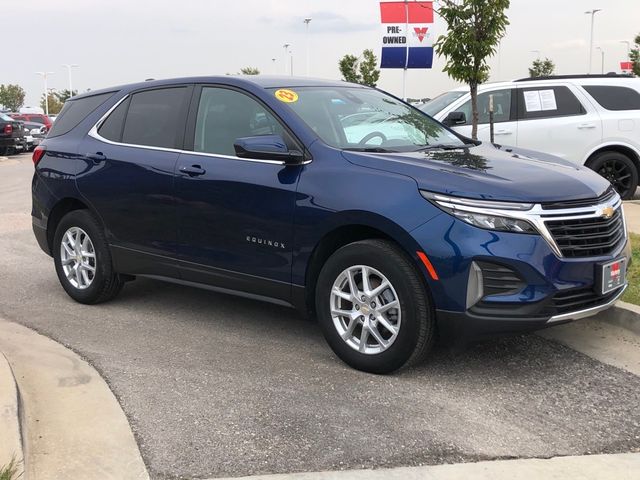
[32,77,630,373]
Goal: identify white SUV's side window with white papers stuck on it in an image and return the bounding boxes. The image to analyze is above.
[518,86,587,120]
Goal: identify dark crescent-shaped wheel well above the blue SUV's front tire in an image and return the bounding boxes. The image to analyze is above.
[305,225,397,314]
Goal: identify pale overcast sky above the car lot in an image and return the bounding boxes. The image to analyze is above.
[0,0,640,105]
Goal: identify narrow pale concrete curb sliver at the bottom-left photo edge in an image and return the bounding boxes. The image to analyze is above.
[0,352,24,470]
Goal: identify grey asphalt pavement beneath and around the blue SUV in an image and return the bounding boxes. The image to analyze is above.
[0,155,640,479]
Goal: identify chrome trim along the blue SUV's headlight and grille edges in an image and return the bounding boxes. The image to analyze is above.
[426,192,628,261]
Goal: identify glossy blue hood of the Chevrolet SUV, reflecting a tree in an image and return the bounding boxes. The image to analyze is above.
[343,144,609,202]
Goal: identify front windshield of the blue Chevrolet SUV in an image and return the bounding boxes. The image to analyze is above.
[276,87,464,152]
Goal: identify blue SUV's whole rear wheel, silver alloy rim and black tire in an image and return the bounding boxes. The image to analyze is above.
[53,210,124,304]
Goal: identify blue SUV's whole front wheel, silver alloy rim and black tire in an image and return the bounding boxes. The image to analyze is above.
[316,240,435,374]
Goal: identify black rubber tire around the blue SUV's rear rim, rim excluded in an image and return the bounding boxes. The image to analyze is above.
[52,210,124,305]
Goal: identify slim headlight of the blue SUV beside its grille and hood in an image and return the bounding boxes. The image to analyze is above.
[420,190,538,234]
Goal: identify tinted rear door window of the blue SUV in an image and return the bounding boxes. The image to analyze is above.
[121,87,189,148]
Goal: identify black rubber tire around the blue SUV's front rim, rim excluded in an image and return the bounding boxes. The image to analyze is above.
[316,239,436,374]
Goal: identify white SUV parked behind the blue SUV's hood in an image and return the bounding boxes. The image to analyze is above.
[420,75,640,198]
